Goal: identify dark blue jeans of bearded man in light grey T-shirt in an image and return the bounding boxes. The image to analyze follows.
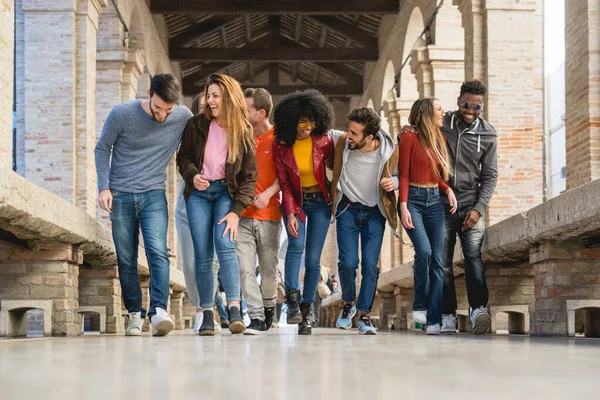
[336,197,385,313]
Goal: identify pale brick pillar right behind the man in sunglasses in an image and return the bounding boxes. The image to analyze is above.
[454,0,543,225]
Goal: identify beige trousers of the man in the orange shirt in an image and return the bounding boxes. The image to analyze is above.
[235,217,281,321]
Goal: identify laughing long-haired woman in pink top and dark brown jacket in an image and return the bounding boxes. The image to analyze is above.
[177,74,257,336]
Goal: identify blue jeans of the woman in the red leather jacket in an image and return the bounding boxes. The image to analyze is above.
[283,194,331,303]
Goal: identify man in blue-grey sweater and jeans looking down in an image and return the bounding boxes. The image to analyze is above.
[95,74,192,336]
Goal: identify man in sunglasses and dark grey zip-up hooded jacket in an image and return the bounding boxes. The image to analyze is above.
[441,80,498,334]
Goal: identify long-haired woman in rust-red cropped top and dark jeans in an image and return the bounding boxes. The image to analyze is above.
[398,97,456,335]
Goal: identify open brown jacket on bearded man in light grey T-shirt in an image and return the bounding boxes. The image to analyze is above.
[331,133,398,233]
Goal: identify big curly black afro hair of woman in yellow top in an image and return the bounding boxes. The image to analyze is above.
[273,89,334,147]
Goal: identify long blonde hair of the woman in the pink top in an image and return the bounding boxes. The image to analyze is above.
[204,74,254,164]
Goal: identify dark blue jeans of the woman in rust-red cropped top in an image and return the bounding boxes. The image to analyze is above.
[405,186,444,325]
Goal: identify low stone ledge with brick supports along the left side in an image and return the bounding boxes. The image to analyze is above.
[0,167,191,336]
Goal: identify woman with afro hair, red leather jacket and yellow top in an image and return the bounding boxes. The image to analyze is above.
[273,89,333,335]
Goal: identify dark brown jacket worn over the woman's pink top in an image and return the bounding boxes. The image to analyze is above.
[177,114,257,216]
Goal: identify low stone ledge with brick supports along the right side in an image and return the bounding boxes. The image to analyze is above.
[321,180,600,337]
